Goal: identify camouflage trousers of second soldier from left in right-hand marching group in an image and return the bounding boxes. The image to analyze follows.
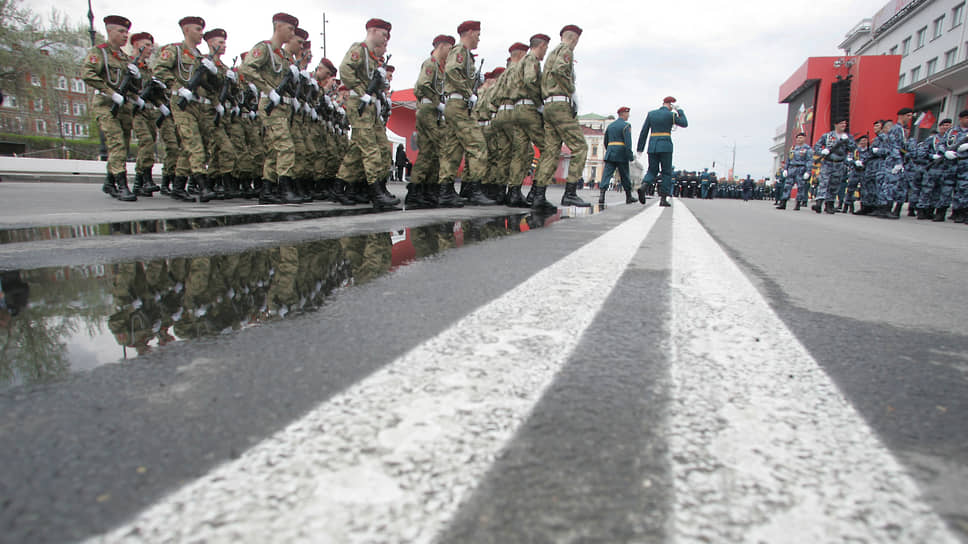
[440,100,487,183]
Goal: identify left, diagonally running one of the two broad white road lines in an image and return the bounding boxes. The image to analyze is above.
[92,206,661,543]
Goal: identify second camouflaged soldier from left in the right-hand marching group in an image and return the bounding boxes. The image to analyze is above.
[438,21,497,206]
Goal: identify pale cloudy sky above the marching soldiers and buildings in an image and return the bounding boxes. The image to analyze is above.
[34,0,887,177]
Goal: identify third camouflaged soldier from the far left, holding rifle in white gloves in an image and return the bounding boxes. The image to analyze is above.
[155,17,218,202]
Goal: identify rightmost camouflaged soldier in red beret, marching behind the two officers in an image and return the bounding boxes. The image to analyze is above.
[531,25,590,212]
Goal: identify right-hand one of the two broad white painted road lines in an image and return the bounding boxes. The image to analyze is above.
[667,204,958,543]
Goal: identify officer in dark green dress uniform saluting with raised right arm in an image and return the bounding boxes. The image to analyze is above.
[636,96,689,206]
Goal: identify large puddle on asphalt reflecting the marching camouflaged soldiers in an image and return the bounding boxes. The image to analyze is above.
[0,206,599,389]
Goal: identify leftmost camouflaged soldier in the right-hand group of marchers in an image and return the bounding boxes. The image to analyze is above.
[403,34,457,208]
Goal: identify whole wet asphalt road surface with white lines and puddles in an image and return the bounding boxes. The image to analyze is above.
[0,183,968,543]
